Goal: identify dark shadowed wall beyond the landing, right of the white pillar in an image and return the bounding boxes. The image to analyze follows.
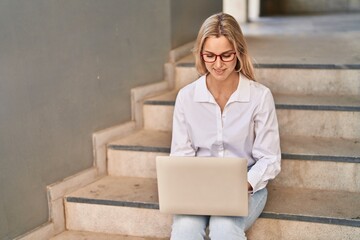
[261,0,360,16]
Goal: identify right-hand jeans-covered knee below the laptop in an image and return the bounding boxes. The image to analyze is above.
[209,216,246,240]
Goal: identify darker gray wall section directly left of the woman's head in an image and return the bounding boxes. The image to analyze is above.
[171,0,222,48]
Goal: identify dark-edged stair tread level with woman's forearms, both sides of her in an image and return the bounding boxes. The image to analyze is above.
[108,129,360,162]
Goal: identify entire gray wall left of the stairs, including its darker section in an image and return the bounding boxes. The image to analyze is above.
[0,0,221,240]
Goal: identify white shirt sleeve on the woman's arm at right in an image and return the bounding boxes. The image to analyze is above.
[248,89,281,193]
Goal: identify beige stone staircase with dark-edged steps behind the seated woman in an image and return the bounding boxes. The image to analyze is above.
[52,50,360,240]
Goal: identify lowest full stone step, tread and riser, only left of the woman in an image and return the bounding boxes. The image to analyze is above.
[65,177,171,238]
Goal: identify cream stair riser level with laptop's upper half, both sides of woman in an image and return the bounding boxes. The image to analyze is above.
[108,149,360,192]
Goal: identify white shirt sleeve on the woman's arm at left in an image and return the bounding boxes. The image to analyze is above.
[170,91,195,156]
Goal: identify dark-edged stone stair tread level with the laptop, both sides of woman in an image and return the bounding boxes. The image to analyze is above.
[66,176,360,226]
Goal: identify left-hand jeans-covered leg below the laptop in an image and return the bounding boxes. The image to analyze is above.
[170,215,209,240]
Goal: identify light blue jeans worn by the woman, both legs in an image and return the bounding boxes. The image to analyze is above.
[171,188,267,240]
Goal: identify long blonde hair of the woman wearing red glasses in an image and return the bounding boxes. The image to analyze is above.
[193,13,255,80]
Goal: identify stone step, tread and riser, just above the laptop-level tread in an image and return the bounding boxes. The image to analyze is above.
[108,130,360,192]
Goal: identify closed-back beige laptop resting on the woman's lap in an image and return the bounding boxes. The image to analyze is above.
[156,156,248,216]
